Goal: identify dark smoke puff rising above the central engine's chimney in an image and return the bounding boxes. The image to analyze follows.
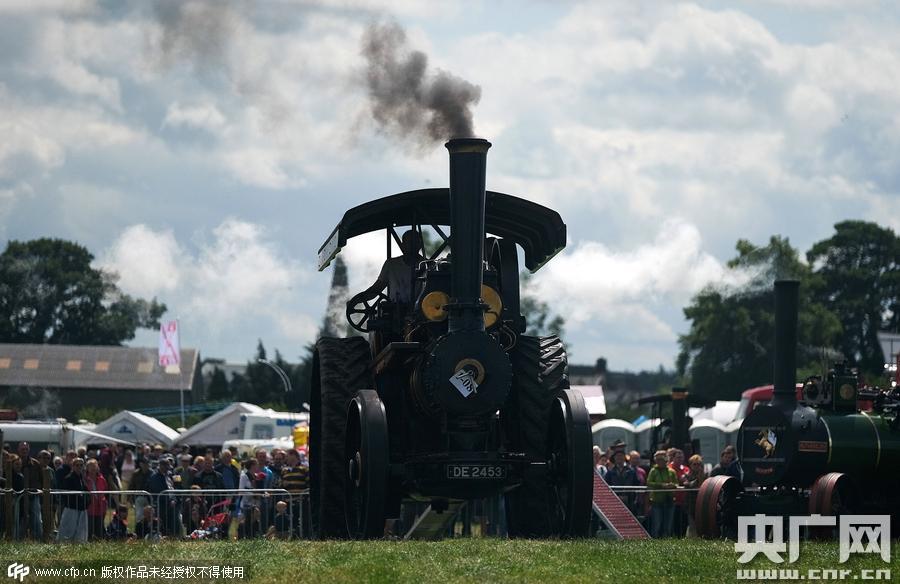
[362,23,481,146]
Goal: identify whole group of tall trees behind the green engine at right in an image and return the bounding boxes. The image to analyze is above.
[676,221,900,399]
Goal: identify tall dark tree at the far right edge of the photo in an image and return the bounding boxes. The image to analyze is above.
[806,221,900,375]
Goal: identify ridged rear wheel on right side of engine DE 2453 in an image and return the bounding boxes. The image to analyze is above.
[500,335,569,537]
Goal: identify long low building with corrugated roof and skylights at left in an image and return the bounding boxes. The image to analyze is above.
[0,343,203,420]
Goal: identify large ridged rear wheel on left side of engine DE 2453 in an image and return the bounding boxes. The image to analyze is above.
[309,337,372,539]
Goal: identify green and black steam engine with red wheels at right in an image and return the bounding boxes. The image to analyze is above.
[695,281,900,538]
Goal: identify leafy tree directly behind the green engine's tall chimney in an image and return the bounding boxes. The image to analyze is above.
[677,236,840,399]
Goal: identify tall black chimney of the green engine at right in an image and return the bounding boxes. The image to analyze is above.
[772,280,800,410]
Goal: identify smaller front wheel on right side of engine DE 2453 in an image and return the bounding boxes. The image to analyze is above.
[547,389,594,537]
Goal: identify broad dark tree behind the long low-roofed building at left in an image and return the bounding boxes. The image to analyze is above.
[0,238,166,345]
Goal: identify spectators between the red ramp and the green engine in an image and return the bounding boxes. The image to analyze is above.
[594,441,740,538]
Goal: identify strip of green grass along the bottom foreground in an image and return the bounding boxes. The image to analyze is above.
[0,538,900,584]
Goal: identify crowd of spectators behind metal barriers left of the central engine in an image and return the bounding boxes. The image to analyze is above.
[0,442,309,541]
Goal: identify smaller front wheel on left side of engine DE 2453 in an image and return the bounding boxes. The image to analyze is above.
[344,389,390,539]
